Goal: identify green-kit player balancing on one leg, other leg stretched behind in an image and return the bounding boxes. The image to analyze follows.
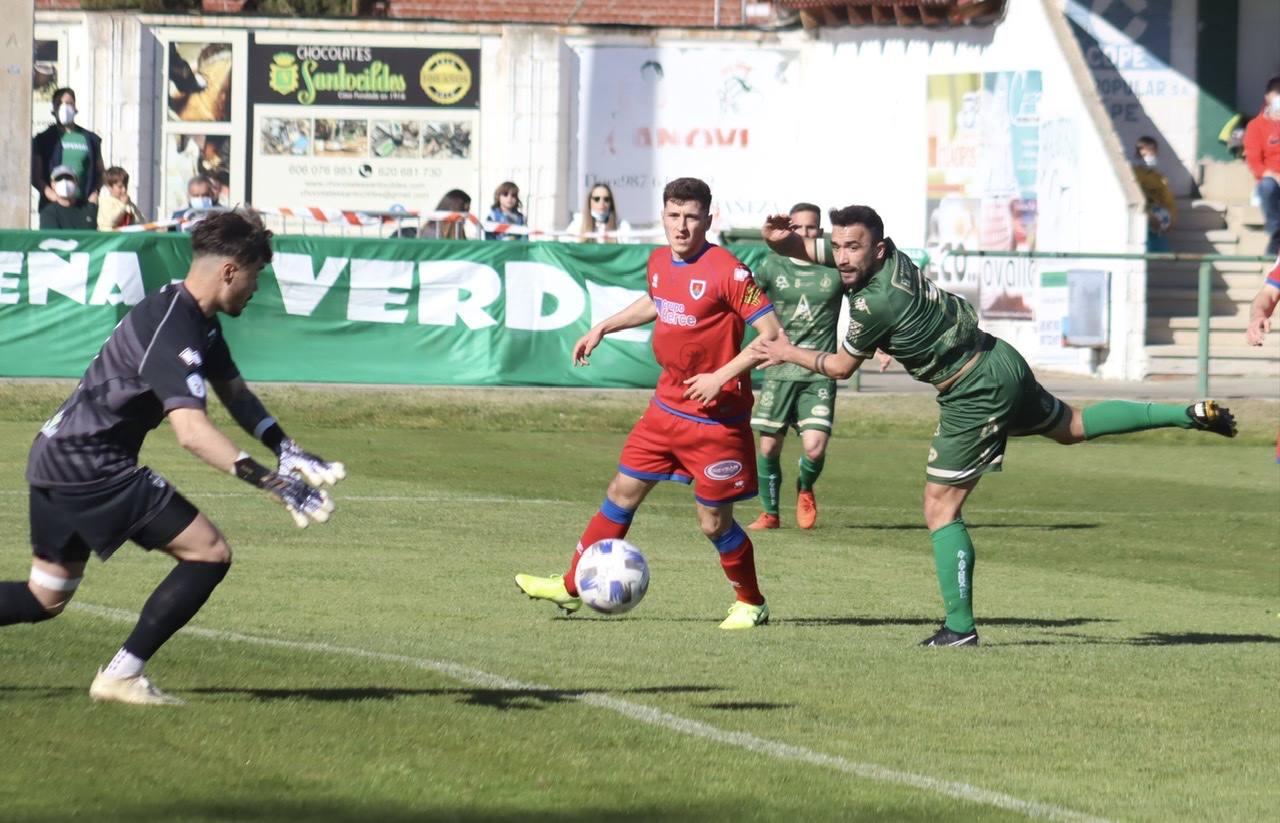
[751,206,1235,646]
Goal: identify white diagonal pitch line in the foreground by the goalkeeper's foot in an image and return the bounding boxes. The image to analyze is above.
[70,603,1107,823]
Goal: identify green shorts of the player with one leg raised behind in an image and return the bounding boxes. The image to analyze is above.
[924,337,1070,486]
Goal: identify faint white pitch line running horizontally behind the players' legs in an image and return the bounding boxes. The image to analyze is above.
[0,489,1275,526]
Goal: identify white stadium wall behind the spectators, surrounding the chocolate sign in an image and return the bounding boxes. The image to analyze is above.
[27,0,1146,378]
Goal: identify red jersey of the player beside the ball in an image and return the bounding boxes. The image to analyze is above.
[648,243,773,422]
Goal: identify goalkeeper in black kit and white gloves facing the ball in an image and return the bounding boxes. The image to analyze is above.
[0,211,346,705]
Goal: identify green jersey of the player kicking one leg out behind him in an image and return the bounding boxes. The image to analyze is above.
[819,238,982,383]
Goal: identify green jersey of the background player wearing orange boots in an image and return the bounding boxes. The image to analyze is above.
[755,255,845,383]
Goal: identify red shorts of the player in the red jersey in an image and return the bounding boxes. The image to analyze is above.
[618,401,759,506]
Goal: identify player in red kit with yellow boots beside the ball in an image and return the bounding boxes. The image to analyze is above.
[516,178,781,628]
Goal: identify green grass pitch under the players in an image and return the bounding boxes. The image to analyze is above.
[0,383,1280,820]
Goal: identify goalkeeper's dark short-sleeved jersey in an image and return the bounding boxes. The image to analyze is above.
[27,284,239,489]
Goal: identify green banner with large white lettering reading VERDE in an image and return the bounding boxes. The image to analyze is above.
[0,230,765,387]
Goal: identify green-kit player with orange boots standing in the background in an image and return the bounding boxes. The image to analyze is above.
[748,204,845,530]
